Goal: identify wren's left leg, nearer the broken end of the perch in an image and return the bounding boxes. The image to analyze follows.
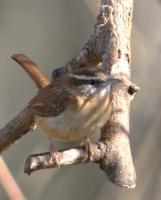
[48,137,60,166]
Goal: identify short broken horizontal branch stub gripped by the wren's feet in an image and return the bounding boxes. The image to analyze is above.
[25,144,103,174]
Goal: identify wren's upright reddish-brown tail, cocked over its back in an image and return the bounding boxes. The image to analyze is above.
[12,54,50,90]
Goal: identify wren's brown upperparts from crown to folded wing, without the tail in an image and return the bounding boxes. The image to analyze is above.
[29,67,107,117]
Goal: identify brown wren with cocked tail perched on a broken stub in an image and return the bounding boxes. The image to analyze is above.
[12,54,115,162]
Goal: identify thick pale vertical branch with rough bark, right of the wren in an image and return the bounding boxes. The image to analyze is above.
[96,0,138,188]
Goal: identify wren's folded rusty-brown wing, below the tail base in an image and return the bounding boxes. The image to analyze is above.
[28,81,74,117]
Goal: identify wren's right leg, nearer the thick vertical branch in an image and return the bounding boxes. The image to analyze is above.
[81,137,93,162]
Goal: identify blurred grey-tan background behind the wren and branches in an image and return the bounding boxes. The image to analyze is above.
[0,0,161,200]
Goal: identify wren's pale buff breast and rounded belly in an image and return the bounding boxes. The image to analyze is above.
[36,88,111,141]
